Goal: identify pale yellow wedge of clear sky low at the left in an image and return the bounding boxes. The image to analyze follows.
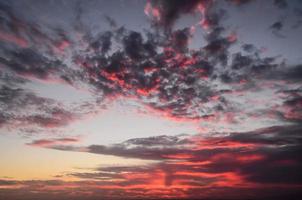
[0,138,151,180]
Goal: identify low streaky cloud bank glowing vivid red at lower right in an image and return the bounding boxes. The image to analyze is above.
[21,125,302,199]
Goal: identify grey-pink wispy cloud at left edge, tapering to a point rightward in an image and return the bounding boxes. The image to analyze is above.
[0,85,89,134]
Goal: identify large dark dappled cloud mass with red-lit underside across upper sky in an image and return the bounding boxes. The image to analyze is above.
[1,1,298,134]
